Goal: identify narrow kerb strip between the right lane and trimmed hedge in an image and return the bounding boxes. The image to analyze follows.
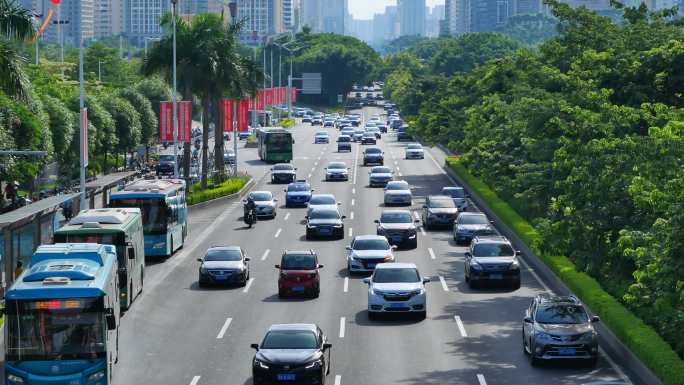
[442,149,662,385]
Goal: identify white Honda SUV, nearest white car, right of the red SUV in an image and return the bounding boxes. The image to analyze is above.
[363,263,430,319]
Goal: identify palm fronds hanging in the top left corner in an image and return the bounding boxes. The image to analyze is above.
[0,0,35,99]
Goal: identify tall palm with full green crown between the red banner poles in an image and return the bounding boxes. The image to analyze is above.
[142,13,256,188]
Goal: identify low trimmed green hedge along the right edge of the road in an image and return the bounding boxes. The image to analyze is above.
[447,157,684,385]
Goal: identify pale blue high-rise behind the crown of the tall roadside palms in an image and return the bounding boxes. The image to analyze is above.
[124,0,168,46]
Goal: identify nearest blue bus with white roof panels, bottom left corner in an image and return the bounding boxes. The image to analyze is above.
[4,243,120,385]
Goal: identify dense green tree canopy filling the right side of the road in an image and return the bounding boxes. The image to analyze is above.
[387,1,684,357]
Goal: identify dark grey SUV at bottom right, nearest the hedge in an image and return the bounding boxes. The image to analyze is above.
[522,294,599,367]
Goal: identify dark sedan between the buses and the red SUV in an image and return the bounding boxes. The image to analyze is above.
[197,246,249,287]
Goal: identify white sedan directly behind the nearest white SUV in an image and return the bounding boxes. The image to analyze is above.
[347,235,396,274]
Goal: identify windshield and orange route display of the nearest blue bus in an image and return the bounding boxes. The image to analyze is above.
[6,298,107,361]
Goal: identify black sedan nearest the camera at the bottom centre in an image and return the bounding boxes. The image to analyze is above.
[252,324,332,385]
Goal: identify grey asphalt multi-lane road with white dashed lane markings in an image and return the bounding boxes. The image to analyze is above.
[108,108,636,385]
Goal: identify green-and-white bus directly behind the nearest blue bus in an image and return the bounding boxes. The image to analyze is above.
[54,208,145,310]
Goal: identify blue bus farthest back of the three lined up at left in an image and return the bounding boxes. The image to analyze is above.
[109,179,188,257]
